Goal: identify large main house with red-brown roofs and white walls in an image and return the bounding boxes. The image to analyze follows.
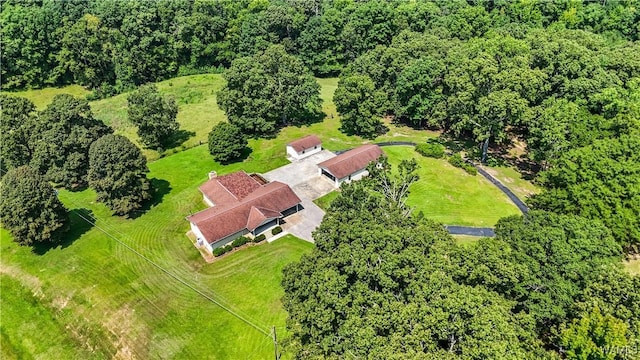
[187,171,302,251]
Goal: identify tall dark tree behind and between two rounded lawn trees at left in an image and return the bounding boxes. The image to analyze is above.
[31,94,112,189]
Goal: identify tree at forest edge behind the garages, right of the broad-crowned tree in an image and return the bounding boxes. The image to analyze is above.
[333,75,384,139]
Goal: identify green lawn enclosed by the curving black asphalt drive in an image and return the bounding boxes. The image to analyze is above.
[383,146,520,227]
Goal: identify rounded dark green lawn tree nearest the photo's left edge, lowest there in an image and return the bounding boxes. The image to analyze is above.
[0,166,69,245]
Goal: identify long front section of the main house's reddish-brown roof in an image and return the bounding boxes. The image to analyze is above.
[187,181,302,244]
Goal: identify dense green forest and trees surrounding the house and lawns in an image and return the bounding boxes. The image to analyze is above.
[0,0,640,360]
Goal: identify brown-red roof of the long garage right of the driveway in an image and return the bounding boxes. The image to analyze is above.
[318,144,384,179]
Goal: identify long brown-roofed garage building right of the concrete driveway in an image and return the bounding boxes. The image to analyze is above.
[318,145,384,186]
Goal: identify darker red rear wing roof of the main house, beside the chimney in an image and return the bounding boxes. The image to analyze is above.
[200,171,260,206]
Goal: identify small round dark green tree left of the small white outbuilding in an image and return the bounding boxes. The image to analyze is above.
[209,122,248,164]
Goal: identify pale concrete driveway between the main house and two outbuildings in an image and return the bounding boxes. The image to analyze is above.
[262,150,336,242]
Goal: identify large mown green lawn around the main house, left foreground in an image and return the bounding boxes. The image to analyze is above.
[0,146,313,359]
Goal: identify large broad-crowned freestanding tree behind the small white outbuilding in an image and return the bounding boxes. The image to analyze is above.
[217,45,321,135]
